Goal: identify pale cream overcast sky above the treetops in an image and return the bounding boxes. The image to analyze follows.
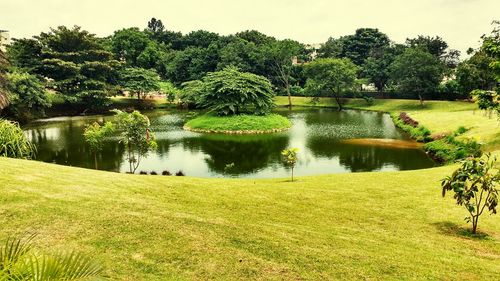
[0,0,500,52]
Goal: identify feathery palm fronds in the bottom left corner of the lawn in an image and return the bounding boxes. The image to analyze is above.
[0,235,103,281]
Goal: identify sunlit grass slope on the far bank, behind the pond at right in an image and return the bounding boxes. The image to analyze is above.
[276,97,500,151]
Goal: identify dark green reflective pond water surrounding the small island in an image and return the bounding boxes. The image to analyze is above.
[24,108,435,178]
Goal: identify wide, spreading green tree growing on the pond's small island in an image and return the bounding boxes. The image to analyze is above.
[199,66,274,115]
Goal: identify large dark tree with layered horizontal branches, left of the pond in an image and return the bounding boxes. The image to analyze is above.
[37,26,118,108]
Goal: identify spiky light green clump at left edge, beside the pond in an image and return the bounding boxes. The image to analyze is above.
[0,119,36,159]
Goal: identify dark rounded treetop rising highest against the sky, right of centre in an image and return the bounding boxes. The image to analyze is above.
[340,28,390,66]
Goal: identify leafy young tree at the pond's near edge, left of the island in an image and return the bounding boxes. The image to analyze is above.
[114,110,157,174]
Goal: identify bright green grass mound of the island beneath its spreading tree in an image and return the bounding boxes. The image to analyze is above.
[184,114,291,133]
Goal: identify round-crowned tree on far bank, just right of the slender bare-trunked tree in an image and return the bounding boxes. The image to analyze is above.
[305,58,358,111]
